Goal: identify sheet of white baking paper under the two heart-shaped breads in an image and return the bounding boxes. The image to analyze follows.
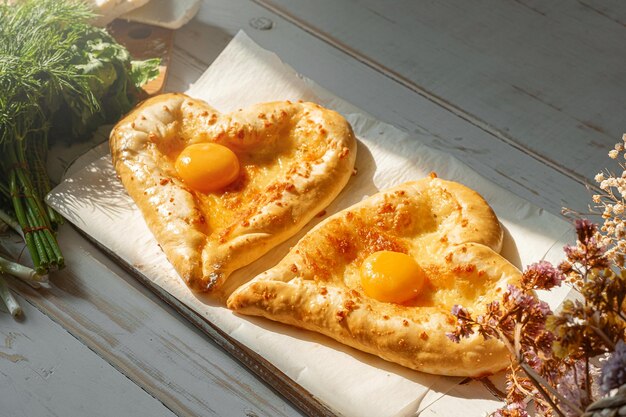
[48,32,570,417]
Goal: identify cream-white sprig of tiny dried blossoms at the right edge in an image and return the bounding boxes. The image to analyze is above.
[593,134,626,267]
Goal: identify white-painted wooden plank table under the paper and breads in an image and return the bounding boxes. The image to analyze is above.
[0,0,626,417]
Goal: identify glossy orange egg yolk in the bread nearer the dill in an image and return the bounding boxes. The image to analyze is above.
[174,143,239,193]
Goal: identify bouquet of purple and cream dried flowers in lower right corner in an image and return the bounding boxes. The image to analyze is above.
[448,135,626,417]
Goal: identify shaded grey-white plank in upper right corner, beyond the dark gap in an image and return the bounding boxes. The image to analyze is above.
[257,0,626,195]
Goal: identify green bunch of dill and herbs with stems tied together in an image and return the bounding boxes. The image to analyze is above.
[0,0,158,274]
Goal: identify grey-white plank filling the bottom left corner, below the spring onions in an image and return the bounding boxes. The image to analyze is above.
[0,290,175,417]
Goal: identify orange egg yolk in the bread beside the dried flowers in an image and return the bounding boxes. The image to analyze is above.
[361,251,426,303]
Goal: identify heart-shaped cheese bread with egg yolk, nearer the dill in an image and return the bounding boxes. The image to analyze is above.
[110,94,356,291]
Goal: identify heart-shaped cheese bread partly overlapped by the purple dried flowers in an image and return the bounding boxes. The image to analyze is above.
[228,176,521,376]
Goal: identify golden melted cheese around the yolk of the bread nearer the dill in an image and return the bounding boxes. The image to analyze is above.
[155,110,327,237]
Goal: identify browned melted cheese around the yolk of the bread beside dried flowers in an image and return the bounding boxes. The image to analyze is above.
[303,184,501,312]
